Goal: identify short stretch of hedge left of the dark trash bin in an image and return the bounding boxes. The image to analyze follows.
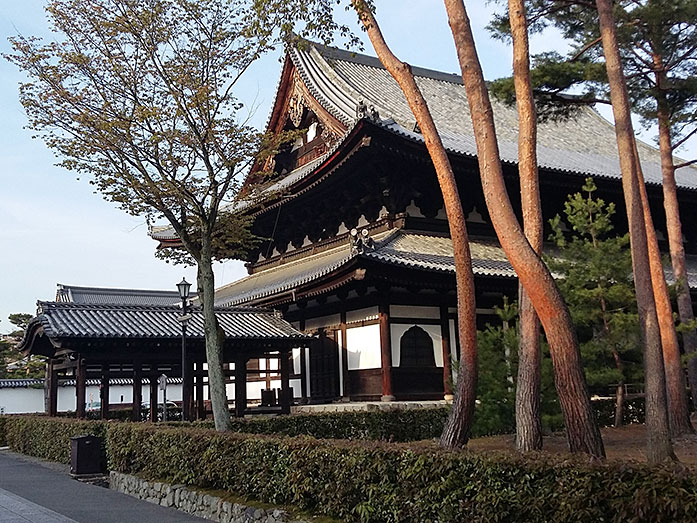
[0,416,107,463]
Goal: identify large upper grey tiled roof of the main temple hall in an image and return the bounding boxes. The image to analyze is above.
[290,44,697,190]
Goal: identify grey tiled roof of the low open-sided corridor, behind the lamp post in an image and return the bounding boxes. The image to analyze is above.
[27,302,304,344]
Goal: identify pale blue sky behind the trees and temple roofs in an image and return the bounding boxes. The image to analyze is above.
[0,0,697,332]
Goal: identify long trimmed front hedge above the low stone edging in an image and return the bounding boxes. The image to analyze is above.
[107,423,697,522]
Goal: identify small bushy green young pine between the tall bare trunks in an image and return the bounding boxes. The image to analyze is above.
[547,178,643,426]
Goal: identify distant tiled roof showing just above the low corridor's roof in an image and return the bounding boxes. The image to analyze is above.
[56,283,188,305]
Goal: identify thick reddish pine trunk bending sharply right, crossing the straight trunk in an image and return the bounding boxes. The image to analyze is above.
[445,0,605,457]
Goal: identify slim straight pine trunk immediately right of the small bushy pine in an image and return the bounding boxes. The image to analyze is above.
[596,0,675,463]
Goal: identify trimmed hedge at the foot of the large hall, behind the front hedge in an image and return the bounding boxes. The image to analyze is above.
[195,407,448,442]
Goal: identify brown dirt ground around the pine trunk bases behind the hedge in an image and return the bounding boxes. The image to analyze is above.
[467,423,697,466]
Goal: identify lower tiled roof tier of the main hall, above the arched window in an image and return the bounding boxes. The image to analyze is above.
[216,230,515,305]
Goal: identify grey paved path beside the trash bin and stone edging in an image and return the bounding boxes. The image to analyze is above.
[0,451,204,523]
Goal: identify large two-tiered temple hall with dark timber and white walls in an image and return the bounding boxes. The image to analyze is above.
[153,43,697,402]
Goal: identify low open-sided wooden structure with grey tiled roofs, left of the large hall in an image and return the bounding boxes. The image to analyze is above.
[17,284,308,421]
